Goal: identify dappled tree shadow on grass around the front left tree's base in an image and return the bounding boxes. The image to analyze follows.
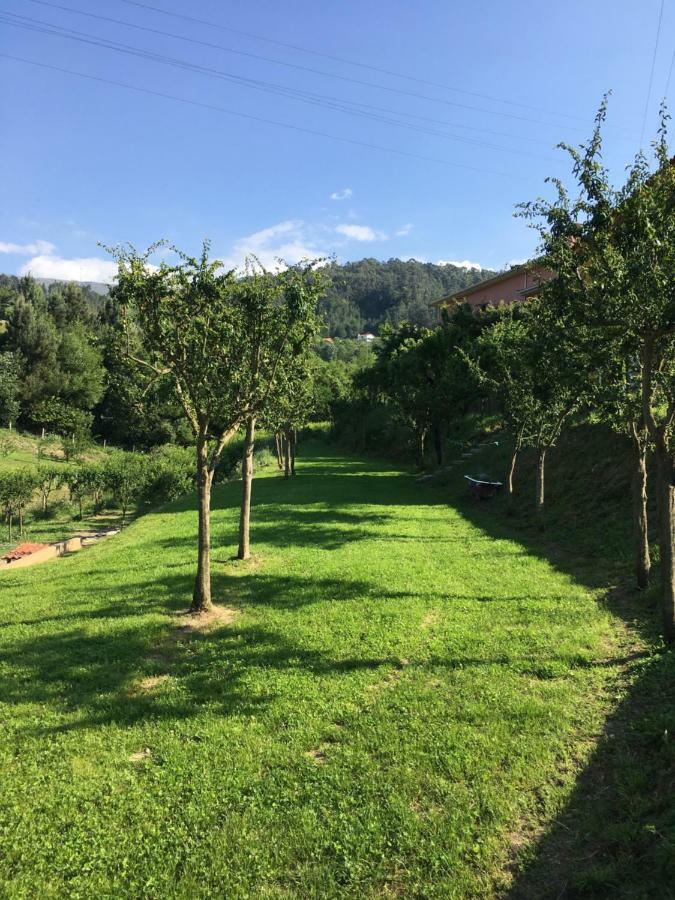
[0,574,404,734]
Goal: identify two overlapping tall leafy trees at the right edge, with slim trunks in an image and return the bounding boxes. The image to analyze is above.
[530,103,675,628]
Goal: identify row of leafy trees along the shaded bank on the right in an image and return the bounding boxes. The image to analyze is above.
[348,103,675,641]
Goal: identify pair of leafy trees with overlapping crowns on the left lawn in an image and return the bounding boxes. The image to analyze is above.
[111,243,325,612]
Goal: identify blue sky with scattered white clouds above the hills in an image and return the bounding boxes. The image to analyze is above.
[0,0,675,280]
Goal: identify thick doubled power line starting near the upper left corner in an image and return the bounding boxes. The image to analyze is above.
[0,13,560,159]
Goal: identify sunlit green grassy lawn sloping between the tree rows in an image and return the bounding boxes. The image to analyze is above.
[0,443,666,898]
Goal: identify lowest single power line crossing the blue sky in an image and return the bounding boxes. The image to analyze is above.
[0,53,520,180]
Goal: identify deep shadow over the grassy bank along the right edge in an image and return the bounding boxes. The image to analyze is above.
[444,429,675,900]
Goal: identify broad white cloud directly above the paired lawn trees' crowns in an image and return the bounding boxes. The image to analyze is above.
[223,219,328,270]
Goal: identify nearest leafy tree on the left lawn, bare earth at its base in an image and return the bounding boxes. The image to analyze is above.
[111,243,248,613]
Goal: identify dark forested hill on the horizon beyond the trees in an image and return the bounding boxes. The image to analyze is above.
[0,259,495,337]
